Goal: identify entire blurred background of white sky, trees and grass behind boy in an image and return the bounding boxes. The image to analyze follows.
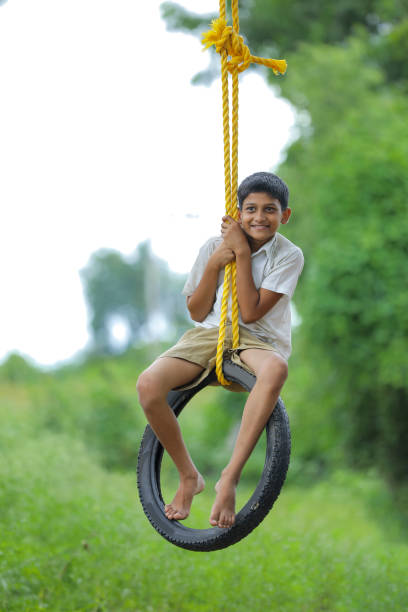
[0,0,408,612]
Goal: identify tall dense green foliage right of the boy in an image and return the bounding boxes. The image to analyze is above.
[280,43,408,482]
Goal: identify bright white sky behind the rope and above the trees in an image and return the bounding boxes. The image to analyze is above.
[0,0,293,365]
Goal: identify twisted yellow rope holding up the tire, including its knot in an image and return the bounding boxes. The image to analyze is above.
[202,0,286,385]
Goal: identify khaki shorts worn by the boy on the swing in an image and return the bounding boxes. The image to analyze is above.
[159,323,277,391]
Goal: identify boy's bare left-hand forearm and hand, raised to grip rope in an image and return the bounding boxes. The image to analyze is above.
[187,242,235,323]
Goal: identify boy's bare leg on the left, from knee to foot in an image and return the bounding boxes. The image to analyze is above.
[137,357,204,520]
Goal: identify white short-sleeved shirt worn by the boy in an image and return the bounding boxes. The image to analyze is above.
[182,233,304,360]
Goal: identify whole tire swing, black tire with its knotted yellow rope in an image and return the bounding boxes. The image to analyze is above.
[137,0,291,551]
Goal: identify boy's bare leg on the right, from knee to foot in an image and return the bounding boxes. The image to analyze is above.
[210,349,288,527]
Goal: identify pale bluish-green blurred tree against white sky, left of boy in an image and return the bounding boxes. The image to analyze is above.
[81,243,187,353]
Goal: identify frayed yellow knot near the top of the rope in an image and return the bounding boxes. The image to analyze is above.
[202,17,286,74]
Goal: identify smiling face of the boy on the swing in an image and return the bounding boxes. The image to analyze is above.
[239,192,292,249]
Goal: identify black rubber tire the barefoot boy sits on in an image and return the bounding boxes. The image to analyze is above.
[137,360,291,551]
